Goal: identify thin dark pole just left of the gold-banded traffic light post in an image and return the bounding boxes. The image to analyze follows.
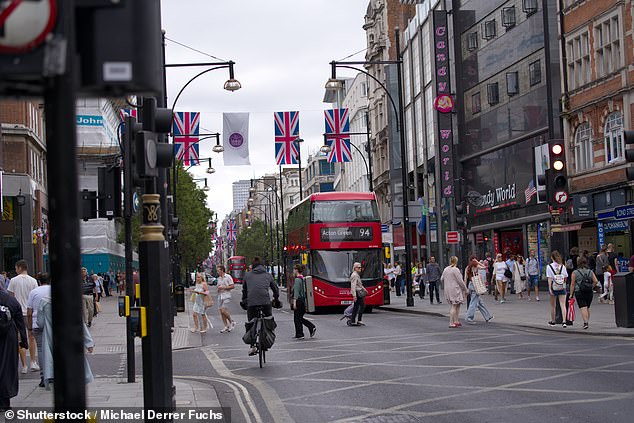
[123,116,136,383]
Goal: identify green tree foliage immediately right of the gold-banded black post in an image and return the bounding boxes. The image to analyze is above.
[176,164,213,269]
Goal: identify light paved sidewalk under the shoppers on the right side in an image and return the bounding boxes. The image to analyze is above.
[380,290,634,337]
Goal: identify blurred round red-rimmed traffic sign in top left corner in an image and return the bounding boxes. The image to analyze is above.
[0,0,57,53]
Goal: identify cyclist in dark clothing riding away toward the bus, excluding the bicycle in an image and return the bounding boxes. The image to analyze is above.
[240,256,280,355]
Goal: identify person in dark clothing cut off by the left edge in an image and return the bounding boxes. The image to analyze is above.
[0,284,29,411]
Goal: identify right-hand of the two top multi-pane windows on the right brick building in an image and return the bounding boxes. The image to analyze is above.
[594,16,622,77]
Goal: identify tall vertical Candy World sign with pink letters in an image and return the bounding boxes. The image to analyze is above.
[434,10,454,198]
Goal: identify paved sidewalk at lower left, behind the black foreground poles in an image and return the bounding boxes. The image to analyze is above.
[11,296,220,408]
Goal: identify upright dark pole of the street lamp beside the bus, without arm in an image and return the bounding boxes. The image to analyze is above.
[395,28,414,307]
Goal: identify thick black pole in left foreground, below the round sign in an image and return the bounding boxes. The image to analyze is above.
[43,0,86,413]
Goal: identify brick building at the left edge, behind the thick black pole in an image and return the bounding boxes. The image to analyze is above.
[0,101,48,274]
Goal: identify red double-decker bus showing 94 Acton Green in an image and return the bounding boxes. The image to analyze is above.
[286,192,384,309]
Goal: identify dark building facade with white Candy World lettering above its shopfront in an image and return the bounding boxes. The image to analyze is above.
[451,0,567,268]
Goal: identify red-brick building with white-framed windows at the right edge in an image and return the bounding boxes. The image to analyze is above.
[560,0,634,257]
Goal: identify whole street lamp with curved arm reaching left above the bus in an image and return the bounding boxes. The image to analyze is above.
[326,29,414,307]
